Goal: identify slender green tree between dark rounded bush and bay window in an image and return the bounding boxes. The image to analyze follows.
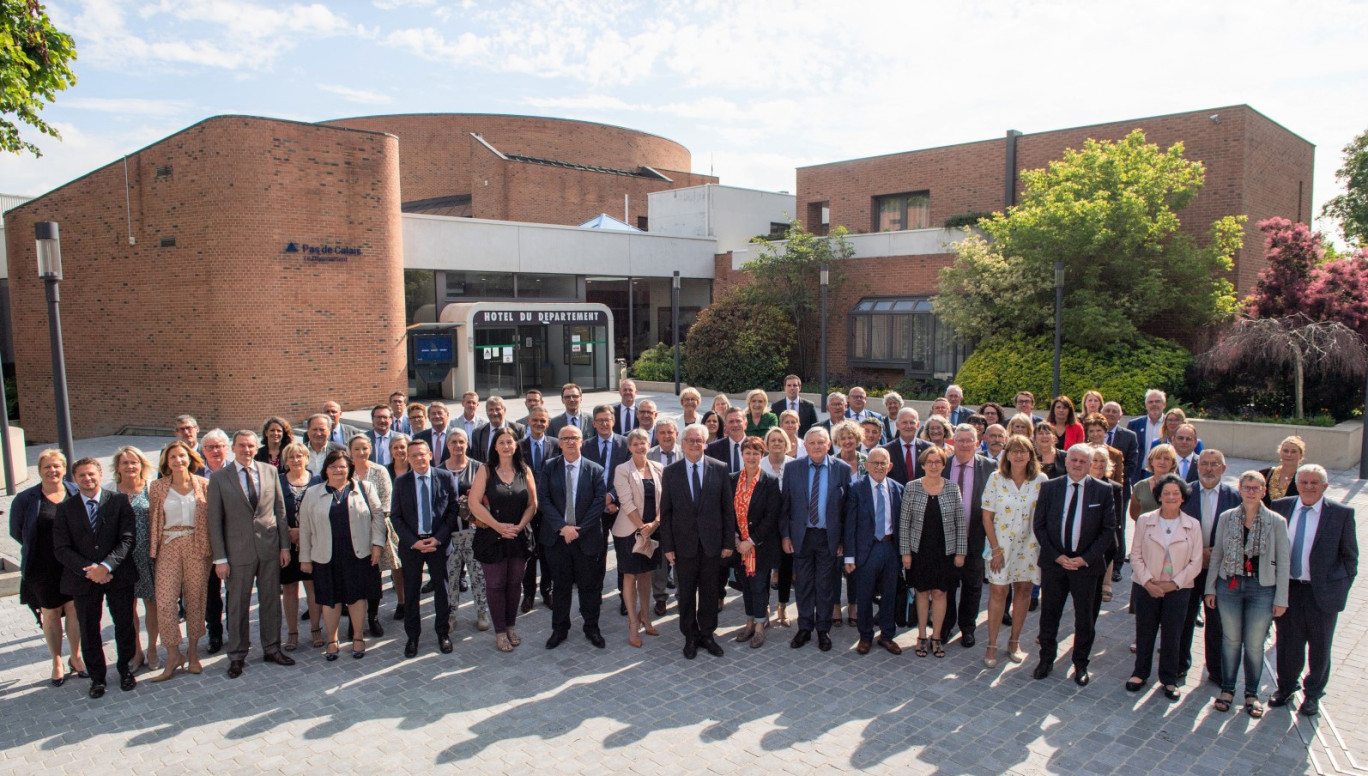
[741,219,855,378]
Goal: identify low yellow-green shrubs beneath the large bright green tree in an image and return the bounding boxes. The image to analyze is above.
[955,335,1193,415]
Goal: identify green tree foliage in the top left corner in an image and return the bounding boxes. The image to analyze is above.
[0,0,77,156]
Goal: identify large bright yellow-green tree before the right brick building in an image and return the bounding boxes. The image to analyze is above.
[934,130,1244,346]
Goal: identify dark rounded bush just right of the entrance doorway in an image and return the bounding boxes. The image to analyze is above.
[689,293,796,393]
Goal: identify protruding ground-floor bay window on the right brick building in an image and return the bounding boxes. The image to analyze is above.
[850,297,973,376]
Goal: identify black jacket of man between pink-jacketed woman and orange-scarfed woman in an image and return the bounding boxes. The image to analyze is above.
[661,456,736,558]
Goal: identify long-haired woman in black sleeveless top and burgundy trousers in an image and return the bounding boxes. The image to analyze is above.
[469,426,536,651]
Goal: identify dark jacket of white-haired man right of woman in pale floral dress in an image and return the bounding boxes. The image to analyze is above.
[1031,475,1116,576]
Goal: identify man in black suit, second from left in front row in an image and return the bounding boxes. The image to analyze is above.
[52,458,137,698]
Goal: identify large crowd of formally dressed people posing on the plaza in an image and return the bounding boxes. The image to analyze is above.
[10,375,1357,717]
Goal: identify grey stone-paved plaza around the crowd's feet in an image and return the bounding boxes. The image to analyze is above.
[0,394,1368,776]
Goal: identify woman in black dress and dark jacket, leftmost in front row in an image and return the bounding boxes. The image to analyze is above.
[10,449,85,687]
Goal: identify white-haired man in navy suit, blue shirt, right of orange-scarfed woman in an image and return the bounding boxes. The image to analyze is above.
[778,427,851,651]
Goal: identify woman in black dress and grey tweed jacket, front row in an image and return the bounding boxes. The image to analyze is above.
[897,446,969,657]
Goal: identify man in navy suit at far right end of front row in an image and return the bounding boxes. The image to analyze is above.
[1269,464,1358,717]
